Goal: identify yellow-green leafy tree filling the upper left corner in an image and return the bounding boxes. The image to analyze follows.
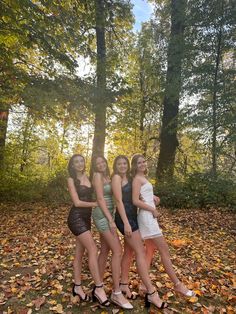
[0,0,92,165]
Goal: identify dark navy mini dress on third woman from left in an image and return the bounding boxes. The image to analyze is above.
[115,181,139,235]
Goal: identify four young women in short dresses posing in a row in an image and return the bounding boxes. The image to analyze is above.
[68,154,194,309]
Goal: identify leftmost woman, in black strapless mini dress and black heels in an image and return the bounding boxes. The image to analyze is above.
[67,154,110,306]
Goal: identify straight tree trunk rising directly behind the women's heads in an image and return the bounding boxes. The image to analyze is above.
[92,0,107,157]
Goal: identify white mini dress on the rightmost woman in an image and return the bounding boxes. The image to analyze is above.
[138,182,162,239]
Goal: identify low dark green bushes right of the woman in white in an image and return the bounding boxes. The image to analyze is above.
[155,172,236,209]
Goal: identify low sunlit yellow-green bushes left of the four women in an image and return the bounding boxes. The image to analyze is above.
[0,156,69,202]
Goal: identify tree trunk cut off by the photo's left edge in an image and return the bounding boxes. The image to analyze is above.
[0,106,9,169]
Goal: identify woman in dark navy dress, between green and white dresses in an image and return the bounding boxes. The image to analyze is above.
[112,155,167,309]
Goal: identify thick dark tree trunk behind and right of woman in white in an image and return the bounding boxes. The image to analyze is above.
[156,0,186,181]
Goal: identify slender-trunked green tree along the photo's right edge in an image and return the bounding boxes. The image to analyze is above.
[183,0,235,176]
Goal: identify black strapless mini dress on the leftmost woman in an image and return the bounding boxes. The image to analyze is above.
[67,185,93,236]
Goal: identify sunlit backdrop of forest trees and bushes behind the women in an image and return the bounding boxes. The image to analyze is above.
[0,0,236,208]
